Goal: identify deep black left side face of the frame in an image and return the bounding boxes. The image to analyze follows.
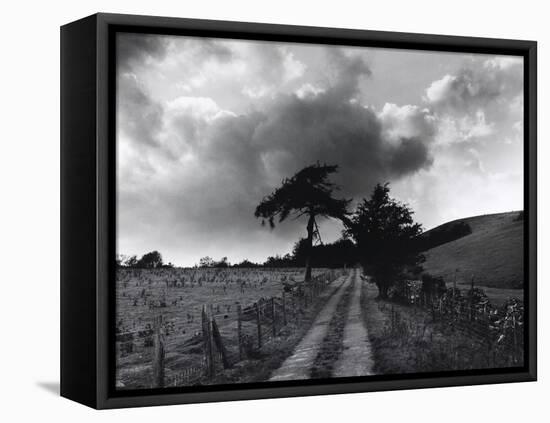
[60,16,97,407]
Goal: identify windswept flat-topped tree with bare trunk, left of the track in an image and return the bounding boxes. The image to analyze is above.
[254,163,351,282]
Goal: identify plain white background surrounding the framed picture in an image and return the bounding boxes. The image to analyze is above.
[0,0,550,423]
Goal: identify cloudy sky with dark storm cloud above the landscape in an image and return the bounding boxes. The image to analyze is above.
[117,34,523,266]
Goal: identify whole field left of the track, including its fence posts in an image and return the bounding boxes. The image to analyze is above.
[116,268,341,389]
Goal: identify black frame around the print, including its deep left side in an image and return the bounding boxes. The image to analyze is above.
[61,13,537,409]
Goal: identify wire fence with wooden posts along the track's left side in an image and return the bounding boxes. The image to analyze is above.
[117,270,344,387]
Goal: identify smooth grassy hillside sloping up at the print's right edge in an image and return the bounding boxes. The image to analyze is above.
[423,212,523,288]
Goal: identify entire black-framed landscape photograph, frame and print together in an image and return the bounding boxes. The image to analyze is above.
[61,14,536,408]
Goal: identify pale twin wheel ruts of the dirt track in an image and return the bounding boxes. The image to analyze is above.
[269,269,373,381]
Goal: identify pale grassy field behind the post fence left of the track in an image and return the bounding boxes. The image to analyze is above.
[116,268,334,388]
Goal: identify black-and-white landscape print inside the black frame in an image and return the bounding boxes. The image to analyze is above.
[113,32,525,391]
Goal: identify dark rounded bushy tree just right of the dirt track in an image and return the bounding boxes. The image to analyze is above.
[346,183,424,298]
